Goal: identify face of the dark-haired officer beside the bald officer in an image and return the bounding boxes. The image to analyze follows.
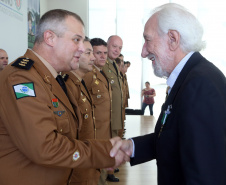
[93,45,108,68]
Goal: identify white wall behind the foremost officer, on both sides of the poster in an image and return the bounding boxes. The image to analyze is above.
[0,0,89,62]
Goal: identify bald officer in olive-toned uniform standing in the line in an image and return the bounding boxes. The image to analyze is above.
[103,35,123,182]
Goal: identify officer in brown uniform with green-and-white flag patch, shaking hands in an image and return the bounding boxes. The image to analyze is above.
[0,9,127,185]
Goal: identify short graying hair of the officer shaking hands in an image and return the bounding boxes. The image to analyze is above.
[35,9,84,43]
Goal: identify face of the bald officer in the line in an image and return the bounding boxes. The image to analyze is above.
[107,36,122,60]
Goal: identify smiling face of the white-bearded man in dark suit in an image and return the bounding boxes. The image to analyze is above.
[141,15,171,77]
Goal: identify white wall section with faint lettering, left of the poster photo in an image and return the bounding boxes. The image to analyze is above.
[0,0,28,62]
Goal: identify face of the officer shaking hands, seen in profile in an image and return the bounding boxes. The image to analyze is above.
[53,16,85,72]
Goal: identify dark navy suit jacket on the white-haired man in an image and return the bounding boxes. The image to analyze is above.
[131,53,226,185]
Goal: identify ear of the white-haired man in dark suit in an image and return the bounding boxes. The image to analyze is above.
[167,30,180,51]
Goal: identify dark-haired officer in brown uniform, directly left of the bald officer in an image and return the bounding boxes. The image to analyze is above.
[84,38,111,185]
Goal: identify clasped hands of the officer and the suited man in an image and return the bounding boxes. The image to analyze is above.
[109,137,133,170]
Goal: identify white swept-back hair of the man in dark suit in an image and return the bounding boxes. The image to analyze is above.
[152,3,206,53]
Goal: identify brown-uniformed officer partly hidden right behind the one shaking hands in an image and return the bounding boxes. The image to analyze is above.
[63,37,99,185]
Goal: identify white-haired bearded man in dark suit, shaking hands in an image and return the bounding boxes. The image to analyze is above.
[112,3,226,185]
